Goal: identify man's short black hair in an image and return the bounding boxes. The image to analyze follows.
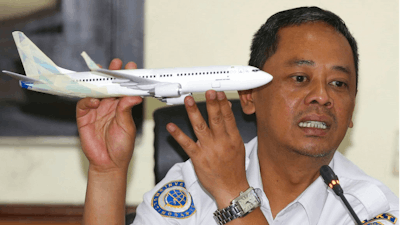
[249,6,358,88]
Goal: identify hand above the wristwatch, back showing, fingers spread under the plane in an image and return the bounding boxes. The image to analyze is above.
[167,90,249,208]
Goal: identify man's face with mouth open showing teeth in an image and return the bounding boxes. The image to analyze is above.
[247,23,356,157]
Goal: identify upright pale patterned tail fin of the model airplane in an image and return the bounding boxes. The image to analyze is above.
[12,31,75,77]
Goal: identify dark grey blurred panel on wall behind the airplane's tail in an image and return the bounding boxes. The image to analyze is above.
[0,0,144,136]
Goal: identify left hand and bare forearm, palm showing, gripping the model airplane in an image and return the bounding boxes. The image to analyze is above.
[76,59,142,224]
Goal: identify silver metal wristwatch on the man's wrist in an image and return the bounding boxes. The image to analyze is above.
[214,187,261,225]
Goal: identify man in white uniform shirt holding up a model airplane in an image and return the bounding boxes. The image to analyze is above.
[77,7,400,225]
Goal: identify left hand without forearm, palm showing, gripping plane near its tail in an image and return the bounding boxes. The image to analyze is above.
[76,59,142,172]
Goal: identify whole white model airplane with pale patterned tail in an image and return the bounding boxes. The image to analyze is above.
[3,31,272,105]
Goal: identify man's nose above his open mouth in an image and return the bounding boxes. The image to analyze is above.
[305,80,333,108]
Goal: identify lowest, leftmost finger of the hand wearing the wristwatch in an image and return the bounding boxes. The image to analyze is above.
[167,123,198,158]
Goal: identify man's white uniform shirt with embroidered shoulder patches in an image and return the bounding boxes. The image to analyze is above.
[133,138,400,225]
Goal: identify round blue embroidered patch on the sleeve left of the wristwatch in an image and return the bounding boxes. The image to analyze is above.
[151,180,196,219]
